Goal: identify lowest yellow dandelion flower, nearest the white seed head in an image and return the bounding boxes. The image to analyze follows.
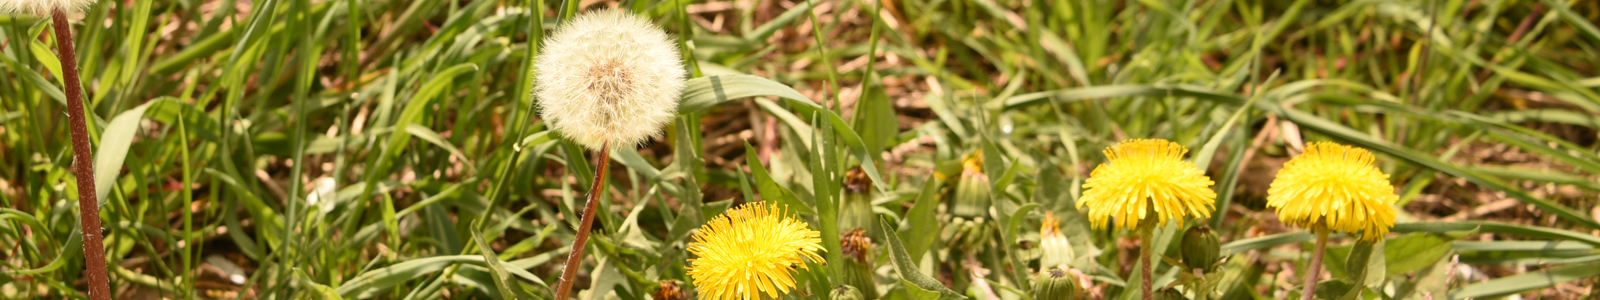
[690,203,824,300]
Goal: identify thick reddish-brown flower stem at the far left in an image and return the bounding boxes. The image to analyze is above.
[50,8,110,300]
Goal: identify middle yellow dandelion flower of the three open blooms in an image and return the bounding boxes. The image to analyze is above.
[1078,139,1216,230]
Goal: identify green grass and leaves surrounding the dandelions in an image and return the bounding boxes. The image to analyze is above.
[0,0,1600,300]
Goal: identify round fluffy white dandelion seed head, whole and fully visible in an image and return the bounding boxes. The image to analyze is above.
[537,9,683,150]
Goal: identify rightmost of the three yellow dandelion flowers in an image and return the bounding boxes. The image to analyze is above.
[1267,142,1400,241]
